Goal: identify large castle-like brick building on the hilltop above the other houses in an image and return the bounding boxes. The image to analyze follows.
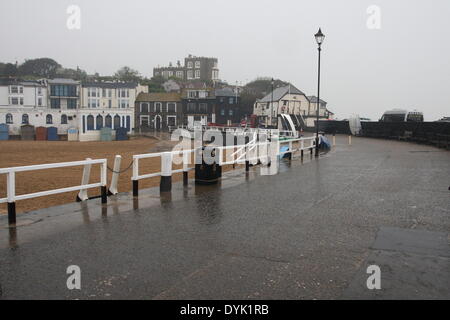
[153,55,219,82]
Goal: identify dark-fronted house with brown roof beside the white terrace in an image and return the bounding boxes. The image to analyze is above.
[134,92,183,132]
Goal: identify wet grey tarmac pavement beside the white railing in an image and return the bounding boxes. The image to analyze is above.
[0,137,450,299]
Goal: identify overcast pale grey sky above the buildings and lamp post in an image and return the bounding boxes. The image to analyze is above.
[0,0,450,120]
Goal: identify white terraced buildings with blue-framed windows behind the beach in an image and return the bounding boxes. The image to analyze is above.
[0,79,148,141]
